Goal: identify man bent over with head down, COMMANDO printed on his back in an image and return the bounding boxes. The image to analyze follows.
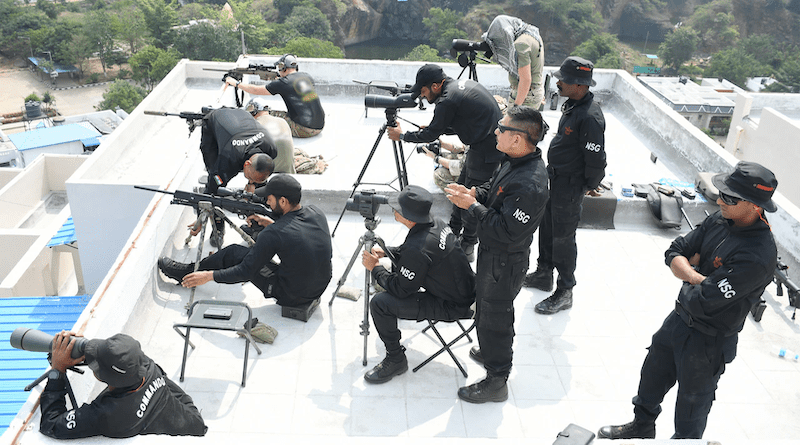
[198,108,278,247]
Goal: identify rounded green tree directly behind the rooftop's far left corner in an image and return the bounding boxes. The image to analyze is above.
[175,23,241,62]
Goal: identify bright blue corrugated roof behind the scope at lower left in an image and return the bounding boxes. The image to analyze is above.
[0,295,91,435]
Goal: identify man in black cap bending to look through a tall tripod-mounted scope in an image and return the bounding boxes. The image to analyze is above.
[387,64,503,260]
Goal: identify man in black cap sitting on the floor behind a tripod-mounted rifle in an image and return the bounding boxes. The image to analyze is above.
[158,175,333,306]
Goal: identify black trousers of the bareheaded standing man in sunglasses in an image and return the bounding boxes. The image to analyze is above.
[475,245,530,377]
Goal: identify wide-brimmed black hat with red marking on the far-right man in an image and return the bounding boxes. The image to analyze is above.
[711,161,778,212]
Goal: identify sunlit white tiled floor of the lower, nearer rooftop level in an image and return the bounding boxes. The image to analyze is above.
[122,214,800,444]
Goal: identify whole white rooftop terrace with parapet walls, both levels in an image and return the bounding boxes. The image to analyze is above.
[2,60,800,445]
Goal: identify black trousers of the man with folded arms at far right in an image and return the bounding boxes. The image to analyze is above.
[633,311,738,439]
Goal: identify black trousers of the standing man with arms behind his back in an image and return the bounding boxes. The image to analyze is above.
[538,175,586,289]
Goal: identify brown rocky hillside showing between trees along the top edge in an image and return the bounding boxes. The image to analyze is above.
[330,0,800,55]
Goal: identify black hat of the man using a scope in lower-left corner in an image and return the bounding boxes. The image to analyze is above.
[84,334,147,388]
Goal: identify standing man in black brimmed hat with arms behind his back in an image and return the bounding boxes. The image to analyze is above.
[525,57,606,314]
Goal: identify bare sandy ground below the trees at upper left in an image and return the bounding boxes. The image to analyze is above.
[0,69,109,116]
